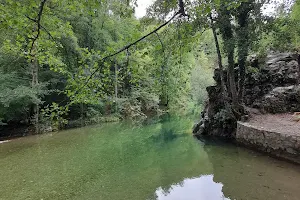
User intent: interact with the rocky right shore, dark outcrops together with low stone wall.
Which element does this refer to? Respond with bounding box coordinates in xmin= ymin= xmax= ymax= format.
xmin=193 ymin=53 xmax=300 ymax=164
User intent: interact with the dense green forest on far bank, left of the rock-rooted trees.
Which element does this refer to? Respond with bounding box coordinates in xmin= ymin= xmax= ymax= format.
xmin=0 ymin=0 xmax=211 ymax=131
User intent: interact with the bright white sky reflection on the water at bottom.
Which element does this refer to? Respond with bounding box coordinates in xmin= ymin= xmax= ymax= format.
xmin=155 ymin=175 xmax=230 ymax=200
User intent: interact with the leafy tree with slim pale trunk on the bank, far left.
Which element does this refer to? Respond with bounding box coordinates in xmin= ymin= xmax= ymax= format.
xmin=0 ymin=0 xmax=79 ymax=132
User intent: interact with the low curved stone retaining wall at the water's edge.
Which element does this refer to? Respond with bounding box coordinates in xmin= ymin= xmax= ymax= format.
xmin=235 ymin=122 xmax=300 ymax=164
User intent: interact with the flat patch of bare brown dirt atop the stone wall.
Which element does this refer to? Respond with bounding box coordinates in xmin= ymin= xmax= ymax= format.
xmin=248 ymin=114 xmax=300 ymax=136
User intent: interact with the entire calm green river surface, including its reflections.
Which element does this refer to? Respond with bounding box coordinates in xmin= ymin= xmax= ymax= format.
xmin=0 ymin=118 xmax=300 ymax=200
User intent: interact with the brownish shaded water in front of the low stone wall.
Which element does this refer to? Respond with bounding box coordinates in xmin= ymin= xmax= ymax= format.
xmin=204 ymin=139 xmax=300 ymax=200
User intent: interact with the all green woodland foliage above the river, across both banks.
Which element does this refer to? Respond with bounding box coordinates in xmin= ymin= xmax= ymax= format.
xmin=0 ymin=0 xmax=300 ymax=132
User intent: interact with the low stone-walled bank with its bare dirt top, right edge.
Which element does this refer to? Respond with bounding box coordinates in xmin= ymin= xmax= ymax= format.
xmin=235 ymin=114 xmax=300 ymax=164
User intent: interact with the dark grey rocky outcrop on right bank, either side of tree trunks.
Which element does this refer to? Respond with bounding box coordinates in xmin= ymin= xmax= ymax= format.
xmin=193 ymin=53 xmax=300 ymax=138
